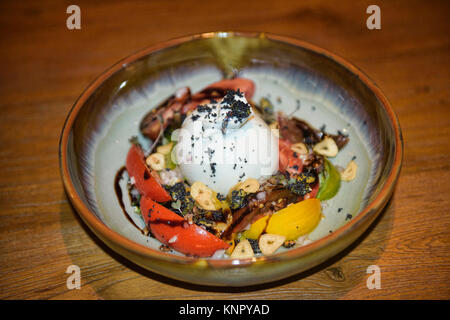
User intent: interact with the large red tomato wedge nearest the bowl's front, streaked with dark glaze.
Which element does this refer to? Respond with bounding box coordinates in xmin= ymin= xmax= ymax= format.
xmin=141 ymin=197 xmax=230 ymax=257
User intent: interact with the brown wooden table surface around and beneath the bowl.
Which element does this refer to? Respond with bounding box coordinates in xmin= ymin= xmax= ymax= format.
xmin=0 ymin=0 xmax=450 ymax=299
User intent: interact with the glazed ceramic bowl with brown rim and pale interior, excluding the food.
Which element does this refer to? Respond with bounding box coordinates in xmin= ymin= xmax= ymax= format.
xmin=60 ymin=32 xmax=403 ymax=286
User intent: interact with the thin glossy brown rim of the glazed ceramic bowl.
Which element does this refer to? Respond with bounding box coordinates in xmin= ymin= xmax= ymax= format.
xmin=59 ymin=32 xmax=403 ymax=268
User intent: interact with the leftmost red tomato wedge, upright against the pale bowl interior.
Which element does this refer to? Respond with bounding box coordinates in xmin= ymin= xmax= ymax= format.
xmin=126 ymin=144 xmax=172 ymax=202
